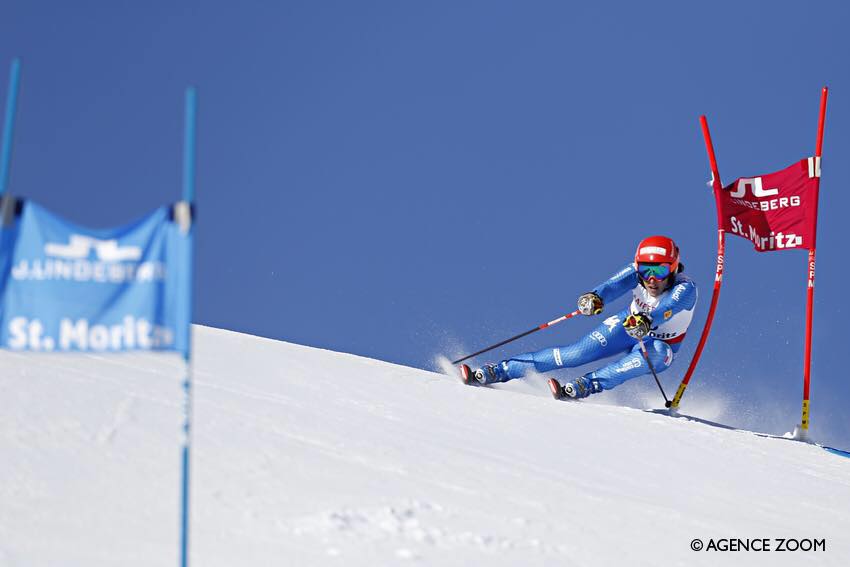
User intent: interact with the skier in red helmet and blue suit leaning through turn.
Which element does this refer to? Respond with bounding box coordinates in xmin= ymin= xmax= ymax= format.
xmin=461 ymin=236 xmax=697 ymax=399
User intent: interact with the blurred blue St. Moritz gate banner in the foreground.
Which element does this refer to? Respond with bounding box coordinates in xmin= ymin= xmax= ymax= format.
xmin=0 ymin=201 xmax=192 ymax=354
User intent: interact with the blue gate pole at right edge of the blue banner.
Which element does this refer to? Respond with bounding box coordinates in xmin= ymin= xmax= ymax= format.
xmin=180 ymin=88 xmax=197 ymax=567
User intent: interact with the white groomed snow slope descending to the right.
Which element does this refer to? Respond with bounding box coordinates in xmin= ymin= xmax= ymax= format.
xmin=0 ymin=327 xmax=850 ymax=567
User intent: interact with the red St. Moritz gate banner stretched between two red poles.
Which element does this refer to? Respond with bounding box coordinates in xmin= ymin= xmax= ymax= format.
xmin=719 ymin=157 xmax=820 ymax=252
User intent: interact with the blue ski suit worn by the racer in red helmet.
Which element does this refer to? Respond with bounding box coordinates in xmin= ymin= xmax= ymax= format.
xmin=497 ymin=264 xmax=697 ymax=390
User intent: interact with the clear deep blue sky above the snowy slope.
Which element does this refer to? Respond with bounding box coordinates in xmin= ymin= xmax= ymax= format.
xmin=0 ymin=0 xmax=850 ymax=446
